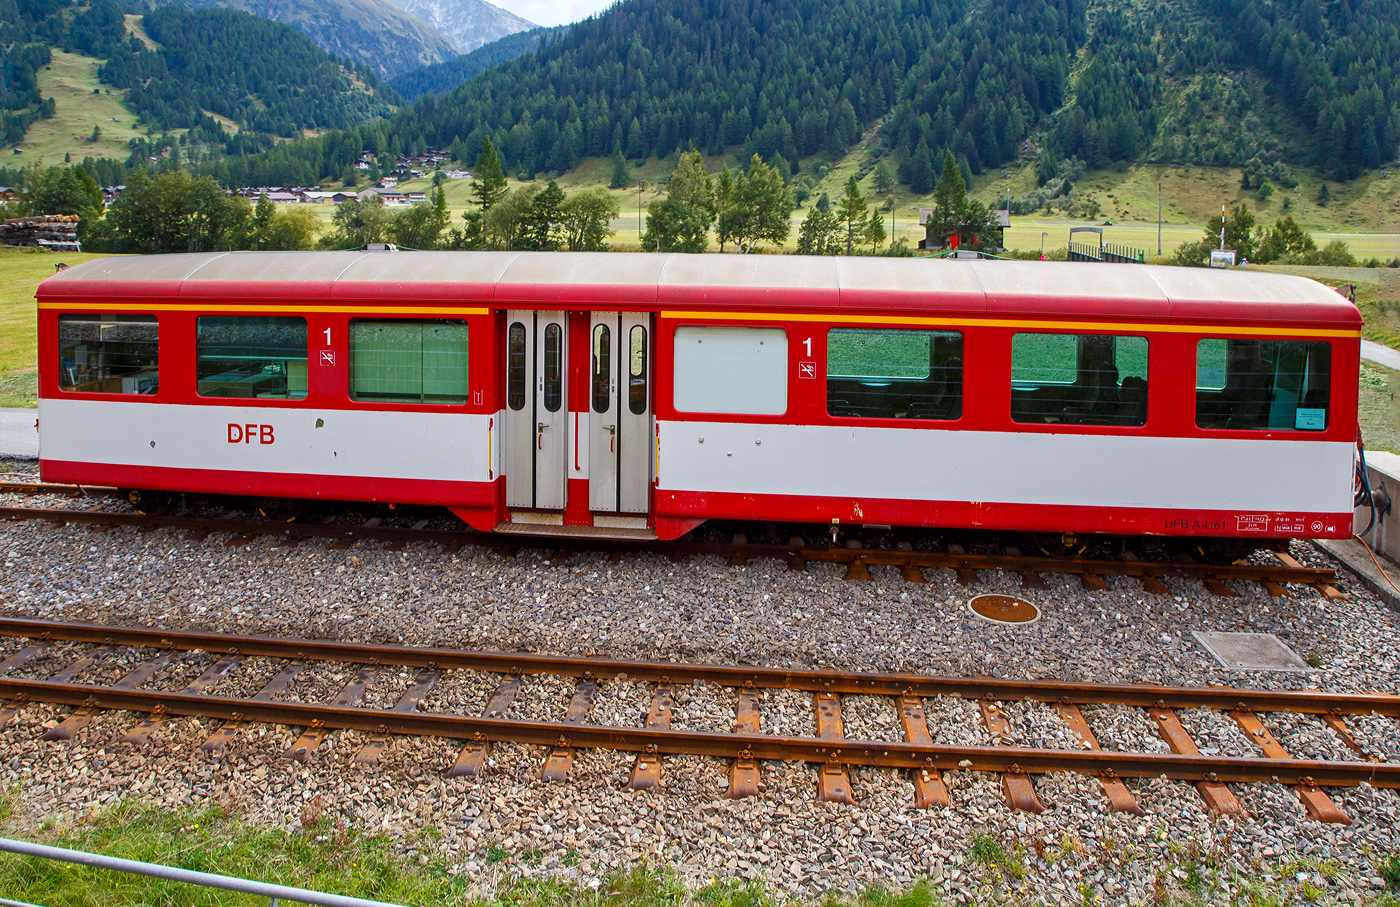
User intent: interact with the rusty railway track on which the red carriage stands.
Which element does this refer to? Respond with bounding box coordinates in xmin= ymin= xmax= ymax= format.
xmin=0 ymin=483 xmax=1345 ymax=599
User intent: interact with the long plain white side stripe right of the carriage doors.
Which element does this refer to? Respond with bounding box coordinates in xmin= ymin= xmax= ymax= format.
xmin=658 ymin=421 xmax=1354 ymax=514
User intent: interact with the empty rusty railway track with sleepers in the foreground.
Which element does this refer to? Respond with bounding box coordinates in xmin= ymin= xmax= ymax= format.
xmin=0 ymin=619 xmax=1400 ymax=823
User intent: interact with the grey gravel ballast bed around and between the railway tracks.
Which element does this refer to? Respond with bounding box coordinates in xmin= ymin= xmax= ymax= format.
xmin=0 ymin=497 xmax=1400 ymax=903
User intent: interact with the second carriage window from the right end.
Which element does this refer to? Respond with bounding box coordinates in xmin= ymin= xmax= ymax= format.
xmin=1011 ymin=333 xmax=1147 ymax=426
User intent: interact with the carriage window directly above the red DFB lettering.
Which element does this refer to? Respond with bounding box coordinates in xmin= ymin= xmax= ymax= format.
xmin=195 ymin=315 xmax=307 ymax=400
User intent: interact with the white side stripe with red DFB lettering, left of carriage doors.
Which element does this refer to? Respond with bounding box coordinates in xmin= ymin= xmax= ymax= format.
xmin=39 ymin=398 xmax=500 ymax=481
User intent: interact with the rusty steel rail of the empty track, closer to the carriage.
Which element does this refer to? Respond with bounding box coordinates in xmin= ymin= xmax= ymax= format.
xmin=0 ymin=617 xmax=1400 ymax=718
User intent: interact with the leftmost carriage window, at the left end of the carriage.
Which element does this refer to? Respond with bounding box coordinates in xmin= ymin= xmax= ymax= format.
xmin=59 ymin=315 xmax=160 ymax=393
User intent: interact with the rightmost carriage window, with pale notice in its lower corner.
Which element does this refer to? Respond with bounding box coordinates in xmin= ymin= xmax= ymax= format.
xmin=1196 ymin=337 xmax=1331 ymax=431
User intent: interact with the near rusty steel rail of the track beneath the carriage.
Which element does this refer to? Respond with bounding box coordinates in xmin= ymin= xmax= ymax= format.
xmin=0 ymin=507 xmax=1337 ymax=585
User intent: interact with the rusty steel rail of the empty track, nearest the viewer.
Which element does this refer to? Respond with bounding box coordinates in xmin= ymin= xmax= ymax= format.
xmin=0 ymin=677 xmax=1400 ymax=788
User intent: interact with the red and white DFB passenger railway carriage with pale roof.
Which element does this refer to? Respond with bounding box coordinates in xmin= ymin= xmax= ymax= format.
xmin=38 ymin=251 xmax=1361 ymax=540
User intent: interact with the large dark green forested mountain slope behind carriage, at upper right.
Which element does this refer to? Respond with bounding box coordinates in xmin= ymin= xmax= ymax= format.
xmin=366 ymin=0 xmax=1400 ymax=179
